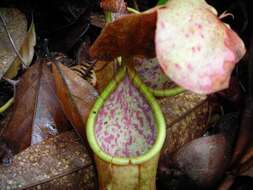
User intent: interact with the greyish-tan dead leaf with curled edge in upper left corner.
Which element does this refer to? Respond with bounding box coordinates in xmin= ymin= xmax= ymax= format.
xmin=0 ymin=9 xmax=36 ymax=78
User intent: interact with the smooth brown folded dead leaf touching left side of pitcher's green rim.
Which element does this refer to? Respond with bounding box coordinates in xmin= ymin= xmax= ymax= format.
xmin=52 ymin=61 xmax=98 ymax=142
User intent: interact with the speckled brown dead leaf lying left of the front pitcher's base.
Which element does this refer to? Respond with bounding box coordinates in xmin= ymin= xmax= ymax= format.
xmin=0 ymin=131 xmax=97 ymax=190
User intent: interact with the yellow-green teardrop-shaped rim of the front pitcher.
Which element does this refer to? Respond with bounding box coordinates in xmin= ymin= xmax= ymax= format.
xmin=86 ymin=66 xmax=166 ymax=165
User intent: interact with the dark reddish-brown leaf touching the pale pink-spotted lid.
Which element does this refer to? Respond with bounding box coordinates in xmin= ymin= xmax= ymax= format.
xmin=90 ymin=11 xmax=157 ymax=61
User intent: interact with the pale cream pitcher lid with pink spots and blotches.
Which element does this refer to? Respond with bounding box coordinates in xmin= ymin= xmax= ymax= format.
xmin=155 ymin=0 xmax=245 ymax=94
